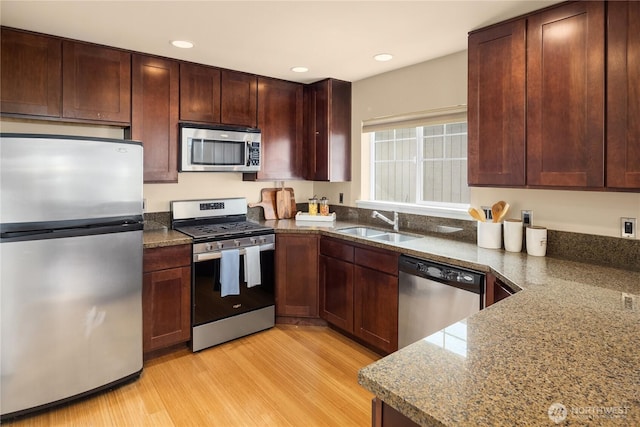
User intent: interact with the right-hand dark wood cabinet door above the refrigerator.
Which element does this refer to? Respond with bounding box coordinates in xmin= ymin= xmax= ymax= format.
xmin=62 ymin=41 xmax=131 ymax=124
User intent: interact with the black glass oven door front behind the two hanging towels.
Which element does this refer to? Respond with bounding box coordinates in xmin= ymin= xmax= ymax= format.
xmin=192 ymin=250 xmax=275 ymax=326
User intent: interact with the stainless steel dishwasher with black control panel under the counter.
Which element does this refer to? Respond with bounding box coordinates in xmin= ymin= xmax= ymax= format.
xmin=398 ymin=255 xmax=485 ymax=349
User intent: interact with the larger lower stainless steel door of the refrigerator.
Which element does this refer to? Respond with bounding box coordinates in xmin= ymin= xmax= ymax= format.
xmin=0 ymin=231 xmax=142 ymax=415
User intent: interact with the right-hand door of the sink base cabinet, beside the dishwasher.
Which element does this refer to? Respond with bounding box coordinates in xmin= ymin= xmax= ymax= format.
xmin=353 ymin=265 xmax=398 ymax=353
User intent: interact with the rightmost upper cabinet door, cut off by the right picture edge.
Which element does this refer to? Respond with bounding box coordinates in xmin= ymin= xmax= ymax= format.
xmin=607 ymin=1 xmax=640 ymax=190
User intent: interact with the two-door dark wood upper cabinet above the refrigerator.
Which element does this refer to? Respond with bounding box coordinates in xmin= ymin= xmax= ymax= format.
xmin=1 ymin=28 xmax=131 ymax=126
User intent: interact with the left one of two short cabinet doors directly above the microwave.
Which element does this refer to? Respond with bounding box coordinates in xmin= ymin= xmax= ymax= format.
xmin=180 ymin=63 xmax=220 ymax=123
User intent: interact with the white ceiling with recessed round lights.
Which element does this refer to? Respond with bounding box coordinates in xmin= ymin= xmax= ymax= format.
xmin=0 ymin=0 xmax=558 ymax=83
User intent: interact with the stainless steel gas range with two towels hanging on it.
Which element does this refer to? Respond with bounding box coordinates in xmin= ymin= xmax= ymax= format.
xmin=171 ymin=198 xmax=275 ymax=352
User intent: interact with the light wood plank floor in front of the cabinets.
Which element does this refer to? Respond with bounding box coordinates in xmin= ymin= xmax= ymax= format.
xmin=7 ymin=325 xmax=379 ymax=427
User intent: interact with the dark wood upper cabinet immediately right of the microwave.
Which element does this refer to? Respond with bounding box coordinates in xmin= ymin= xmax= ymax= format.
xmin=243 ymin=77 xmax=304 ymax=181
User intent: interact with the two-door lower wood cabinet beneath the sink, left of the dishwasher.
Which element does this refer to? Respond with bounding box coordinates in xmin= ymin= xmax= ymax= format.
xmin=320 ymin=237 xmax=399 ymax=353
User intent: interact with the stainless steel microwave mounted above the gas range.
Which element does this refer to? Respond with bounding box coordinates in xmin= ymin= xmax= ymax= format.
xmin=178 ymin=123 xmax=262 ymax=172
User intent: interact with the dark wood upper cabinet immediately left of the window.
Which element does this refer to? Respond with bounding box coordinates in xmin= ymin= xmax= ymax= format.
xmin=304 ymin=79 xmax=351 ymax=182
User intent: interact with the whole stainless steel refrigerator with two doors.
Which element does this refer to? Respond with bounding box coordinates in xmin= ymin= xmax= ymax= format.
xmin=0 ymin=134 xmax=143 ymax=419
